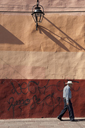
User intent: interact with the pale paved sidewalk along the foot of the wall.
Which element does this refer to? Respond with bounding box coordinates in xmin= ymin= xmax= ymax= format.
xmin=0 ymin=118 xmax=85 ymax=128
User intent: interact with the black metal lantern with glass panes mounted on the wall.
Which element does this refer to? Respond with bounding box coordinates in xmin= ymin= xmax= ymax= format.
xmin=32 ymin=0 xmax=44 ymax=30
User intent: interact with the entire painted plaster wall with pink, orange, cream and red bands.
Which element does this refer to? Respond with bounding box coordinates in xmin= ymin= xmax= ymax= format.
xmin=0 ymin=0 xmax=85 ymax=119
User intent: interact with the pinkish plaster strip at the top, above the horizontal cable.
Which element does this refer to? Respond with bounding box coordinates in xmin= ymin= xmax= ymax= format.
xmin=0 ymin=0 xmax=85 ymax=11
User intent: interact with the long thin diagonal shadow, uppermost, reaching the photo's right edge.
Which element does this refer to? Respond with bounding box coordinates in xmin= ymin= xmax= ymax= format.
xmin=44 ymin=17 xmax=85 ymax=51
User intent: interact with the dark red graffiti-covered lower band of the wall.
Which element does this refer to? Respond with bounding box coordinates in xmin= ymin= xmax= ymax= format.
xmin=0 ymin=79 xmax=85 ymax=119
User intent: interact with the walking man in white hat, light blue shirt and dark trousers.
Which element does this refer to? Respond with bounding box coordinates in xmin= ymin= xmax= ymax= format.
xmin=57 ymin=81 xmax=74 ymax=121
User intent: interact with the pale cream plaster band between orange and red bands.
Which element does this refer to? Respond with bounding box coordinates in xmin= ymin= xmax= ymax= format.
xmin=0 ymin=51 xmax=85 ymax=79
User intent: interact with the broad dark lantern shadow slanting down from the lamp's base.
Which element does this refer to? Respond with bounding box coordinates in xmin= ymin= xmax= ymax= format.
xmin=39 ymin=26 xmax=69 ymax=52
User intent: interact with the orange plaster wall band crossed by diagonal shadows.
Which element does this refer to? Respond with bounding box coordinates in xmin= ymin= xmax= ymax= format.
xmin=0 ymin=13 xmax=85 ymax=52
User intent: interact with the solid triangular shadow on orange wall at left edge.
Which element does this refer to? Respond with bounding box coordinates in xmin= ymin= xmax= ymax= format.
xmin=0 ymin=25 xmax=24 ymax=45
